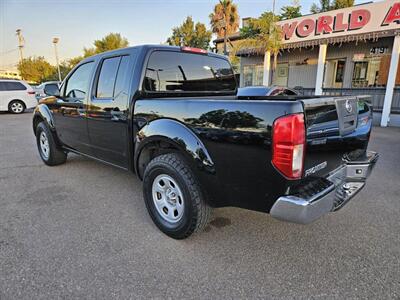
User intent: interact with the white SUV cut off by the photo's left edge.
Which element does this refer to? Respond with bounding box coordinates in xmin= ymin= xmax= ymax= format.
xmin=0 ymin=79 xmax=37 ymax=114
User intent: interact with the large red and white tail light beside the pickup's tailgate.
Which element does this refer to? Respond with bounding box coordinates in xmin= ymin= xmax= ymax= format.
xmin=272 ymin=114 xmax=306 ymax=179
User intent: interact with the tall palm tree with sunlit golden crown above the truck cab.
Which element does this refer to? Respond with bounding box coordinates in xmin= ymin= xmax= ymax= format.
xmin=209 ymin=0 xmax=239 ymax=55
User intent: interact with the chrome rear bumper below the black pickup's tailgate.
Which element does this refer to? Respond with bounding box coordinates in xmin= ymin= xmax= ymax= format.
xmin=270 ymin=151 xmax=379 ymax=224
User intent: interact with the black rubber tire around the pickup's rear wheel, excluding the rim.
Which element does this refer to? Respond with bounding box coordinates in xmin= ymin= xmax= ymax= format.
xmin=143 ymin=153 xmax=212 ymax=239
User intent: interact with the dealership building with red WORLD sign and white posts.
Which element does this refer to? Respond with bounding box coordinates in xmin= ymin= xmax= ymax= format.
xmin=217 ymin=0 xmax=400 ymax=126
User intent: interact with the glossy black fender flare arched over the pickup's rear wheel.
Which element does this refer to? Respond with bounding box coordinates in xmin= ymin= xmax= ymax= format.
xmin=135 ymin=119 xmax=215 ymax=177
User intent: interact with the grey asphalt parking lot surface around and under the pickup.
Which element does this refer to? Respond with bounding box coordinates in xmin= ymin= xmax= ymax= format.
xmin=0 ymin=113 xmax=400 ymax=300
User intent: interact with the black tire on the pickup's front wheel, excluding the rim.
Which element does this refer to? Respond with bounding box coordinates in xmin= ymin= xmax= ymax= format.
xmin=36 ymin=122 xmax=67 ymax=166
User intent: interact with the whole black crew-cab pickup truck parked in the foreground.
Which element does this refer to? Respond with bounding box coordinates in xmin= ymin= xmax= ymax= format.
xmin=33 ymin=45 xmax=378 ymax=239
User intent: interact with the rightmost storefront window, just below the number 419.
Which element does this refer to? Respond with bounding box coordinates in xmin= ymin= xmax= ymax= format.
xmin=352 ymin=57 xmax=381 ymax=87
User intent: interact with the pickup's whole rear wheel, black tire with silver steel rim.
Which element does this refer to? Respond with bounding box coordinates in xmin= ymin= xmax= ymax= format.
xmin=143 ymin=153 xmax=211 ymax=239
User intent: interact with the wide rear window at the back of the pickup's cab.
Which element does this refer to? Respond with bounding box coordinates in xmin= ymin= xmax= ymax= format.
xmin=144 ymin=51 xmax=236 ymax=93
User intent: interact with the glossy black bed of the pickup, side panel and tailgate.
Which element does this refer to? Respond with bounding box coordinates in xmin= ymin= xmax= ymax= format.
xmin=135 ymin=95 xmax=372 ymax=211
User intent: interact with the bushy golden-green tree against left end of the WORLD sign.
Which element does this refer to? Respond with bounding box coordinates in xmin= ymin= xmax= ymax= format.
xmin=233 ymin=12 xmax=282 ymax=68
